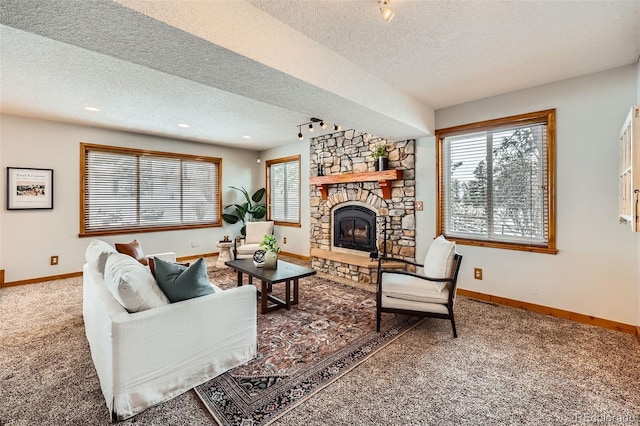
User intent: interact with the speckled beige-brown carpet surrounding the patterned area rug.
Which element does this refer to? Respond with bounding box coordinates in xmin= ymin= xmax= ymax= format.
xmin=0 ymin=256 xmax=640 ymax=425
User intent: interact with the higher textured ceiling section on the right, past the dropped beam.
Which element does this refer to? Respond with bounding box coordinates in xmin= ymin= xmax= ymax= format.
xmin=248 ymin=0 xmax=640 ymax=108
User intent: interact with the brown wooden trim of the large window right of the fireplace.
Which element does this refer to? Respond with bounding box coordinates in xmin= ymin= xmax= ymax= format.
xmin=435 ymin=109 xmax=558 ymax=254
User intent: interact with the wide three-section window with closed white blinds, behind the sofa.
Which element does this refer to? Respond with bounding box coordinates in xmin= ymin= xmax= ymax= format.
xmin=80 ymin=143 xmax=221 ymax=235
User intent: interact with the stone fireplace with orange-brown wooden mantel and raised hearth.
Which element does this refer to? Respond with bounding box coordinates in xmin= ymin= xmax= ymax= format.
xmin=310 ymin=130 xmax=415 ymax=283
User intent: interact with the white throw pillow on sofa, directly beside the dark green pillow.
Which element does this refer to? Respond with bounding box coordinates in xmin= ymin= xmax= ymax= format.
xmin=104 ymin=253 xmax=169 ymax=313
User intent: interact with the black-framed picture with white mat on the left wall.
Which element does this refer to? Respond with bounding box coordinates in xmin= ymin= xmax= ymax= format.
xmin=7 ymin=167 xmax=53 ymax=210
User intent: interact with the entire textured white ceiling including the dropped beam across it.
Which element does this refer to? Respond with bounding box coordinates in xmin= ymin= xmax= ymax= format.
xmin=0 ymin=0 xmax=640 ymax=150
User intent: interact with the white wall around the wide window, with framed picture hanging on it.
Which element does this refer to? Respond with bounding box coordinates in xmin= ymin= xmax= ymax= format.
xmin=0 ymin=115 xmax=261 ymax=281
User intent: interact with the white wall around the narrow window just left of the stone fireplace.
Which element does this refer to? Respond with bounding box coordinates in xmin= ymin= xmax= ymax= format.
xmin=260 ymin=138 xmax=311 ymax=256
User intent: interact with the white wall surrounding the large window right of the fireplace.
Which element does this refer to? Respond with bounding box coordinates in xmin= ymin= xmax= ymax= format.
xmin=416 ymin=65 xmax=640 ymax=324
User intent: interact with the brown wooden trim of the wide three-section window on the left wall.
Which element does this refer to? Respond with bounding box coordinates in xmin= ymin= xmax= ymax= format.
xmin=78 ymin=142 xmax=222 ymax=237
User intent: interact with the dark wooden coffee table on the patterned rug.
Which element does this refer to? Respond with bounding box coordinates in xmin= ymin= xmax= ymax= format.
xmin=225 ymin=259 xmax=316 ymax=314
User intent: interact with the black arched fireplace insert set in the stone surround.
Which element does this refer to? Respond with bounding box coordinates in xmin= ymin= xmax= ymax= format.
xmin=333 ymin=206 xmax=377 ymax=253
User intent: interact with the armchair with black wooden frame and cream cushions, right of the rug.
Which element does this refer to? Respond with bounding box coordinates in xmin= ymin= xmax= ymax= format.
xmin=376 ymin=236 xmax=462 ymax=337
